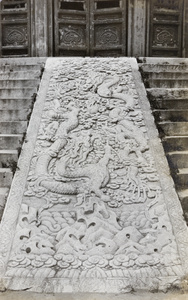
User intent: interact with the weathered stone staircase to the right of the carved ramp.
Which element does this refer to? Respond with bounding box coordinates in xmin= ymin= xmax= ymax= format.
xmin=138 ymin=58 xmax=188 ymax=224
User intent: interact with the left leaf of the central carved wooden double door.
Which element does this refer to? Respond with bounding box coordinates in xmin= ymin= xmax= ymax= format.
xmin=54 ymin=0 xmax=89 ymax=56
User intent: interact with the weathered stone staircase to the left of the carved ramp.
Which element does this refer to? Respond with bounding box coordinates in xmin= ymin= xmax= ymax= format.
xmin=0 ymin=58 xmax=45 ymax=219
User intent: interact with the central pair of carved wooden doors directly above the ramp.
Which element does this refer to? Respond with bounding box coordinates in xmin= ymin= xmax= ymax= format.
xmin=54 ymin=0 xmax=126 ymax=56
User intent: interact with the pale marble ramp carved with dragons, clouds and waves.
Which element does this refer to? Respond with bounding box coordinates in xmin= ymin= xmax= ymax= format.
xmin=0 ymin=58 xmax=188 ymax=293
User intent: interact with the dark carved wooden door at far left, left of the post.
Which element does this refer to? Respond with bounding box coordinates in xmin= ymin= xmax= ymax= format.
xmin=0 ymin=0 xmax=30 ymax=57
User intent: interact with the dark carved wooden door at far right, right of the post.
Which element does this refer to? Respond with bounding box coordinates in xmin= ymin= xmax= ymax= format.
xmin=150 ymin=0 xmax=183 ymax=57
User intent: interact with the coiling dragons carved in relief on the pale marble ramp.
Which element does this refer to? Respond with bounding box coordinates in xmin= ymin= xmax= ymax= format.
xmin=26 ymin=76 xmax=146 ymax=201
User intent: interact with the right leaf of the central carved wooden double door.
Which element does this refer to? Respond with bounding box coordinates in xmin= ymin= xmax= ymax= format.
xmin=90 ymin=0 xmax=127 ymax=56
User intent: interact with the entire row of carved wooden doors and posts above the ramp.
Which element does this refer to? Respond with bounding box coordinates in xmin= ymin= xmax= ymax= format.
xmin=0 ymin=0 xmax=185 ymax=57
